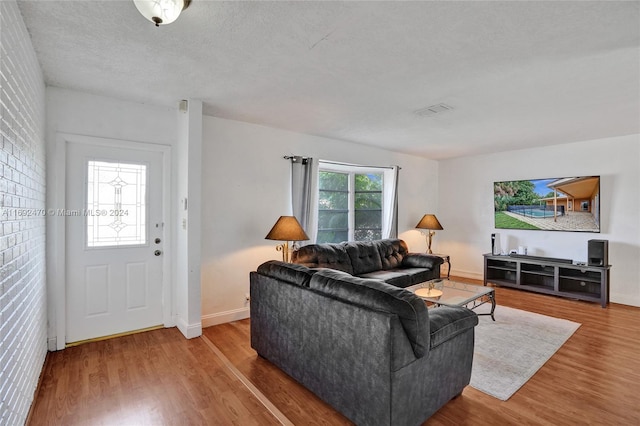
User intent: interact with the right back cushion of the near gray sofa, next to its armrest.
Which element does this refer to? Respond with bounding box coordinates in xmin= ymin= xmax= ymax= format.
xmin=309 ymin=269 xmax=429 ymax=358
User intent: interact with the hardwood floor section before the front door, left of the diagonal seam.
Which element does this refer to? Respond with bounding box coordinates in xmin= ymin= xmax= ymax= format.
xmin=28 ymin=328 xmax=279 ymax=426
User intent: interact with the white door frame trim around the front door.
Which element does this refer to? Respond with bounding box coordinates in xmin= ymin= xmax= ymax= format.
xmin=47 ymin=133 xmax=175 ymax=350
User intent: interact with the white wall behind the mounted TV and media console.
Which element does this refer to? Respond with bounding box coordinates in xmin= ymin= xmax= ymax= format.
xmin=436 ymin=135 xmax=640 ymax=306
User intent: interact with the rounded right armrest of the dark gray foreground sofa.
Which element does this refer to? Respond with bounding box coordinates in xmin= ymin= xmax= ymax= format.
xmin=429 ymin=306 xmax=478 ymax=349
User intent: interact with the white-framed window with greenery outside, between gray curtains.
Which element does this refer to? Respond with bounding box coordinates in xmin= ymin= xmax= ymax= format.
xmin=316 ymin=162 xmax=394 ymax=243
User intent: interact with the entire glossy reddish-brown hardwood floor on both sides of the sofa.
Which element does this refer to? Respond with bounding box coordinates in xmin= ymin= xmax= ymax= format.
xmin=28 ymin=280 xmax=640 ymax=425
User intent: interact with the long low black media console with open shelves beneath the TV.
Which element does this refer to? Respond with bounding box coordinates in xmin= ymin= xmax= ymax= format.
xmin=484 ymin=254 xmax=611 ymax=308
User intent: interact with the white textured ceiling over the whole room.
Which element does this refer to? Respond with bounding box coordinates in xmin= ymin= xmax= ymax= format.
xmin=18 ymin=0 xmax=640 ymax=159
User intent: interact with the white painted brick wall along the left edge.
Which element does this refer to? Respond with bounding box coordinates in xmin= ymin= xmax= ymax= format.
xmin=0 ymin=1 xmax=47 ymax=426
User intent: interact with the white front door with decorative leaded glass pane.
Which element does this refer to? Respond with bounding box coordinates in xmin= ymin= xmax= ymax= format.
xmin=63 ymin=143 xmax=165 ymax=343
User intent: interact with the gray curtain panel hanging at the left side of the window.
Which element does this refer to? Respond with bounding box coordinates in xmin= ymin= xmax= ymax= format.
xmin=289 ymin=155 xmax=313 ymax=236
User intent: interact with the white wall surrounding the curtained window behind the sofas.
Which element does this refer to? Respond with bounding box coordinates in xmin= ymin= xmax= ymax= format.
xmin=202 ymin=116 xmax=438 ymax=326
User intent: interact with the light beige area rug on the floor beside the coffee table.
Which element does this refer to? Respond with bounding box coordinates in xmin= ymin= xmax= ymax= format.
xmin=471 ymin=305 xmax=580 ymax=401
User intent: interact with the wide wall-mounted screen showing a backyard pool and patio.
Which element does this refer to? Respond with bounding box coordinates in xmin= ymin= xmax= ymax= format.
xmin=493 ymin=176 xmax=600 ymax=232
